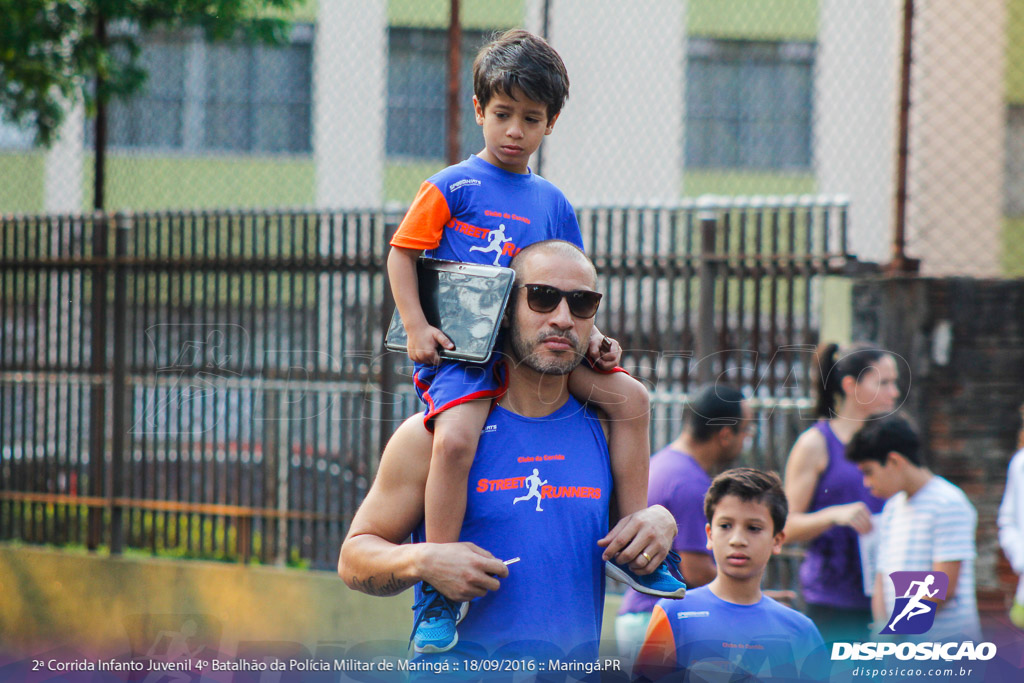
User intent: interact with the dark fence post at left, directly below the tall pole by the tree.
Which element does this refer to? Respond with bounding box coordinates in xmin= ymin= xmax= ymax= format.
xmin=86 ymin=211 xmax=109 ymax=551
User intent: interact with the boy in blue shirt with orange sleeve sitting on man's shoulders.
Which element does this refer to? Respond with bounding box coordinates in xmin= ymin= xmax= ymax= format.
xmin=387 ymin=29 xmax=686 ymax=652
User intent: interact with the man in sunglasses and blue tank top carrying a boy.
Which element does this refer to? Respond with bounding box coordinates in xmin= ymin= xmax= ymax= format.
xmin=338 ymin=241 xmax=677 ymax=676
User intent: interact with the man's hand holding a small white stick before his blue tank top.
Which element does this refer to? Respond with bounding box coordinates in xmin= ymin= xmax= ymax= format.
xmin=419 ymin=543 xmax=509 ymax=602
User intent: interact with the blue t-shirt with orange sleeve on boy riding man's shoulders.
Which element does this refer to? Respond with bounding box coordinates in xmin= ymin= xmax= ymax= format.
xmin=391 ymin=155 xmax=583 ymax=266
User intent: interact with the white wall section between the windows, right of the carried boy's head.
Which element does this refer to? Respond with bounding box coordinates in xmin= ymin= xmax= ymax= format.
xmin=543 ymin=0 xmax=686 ymax=206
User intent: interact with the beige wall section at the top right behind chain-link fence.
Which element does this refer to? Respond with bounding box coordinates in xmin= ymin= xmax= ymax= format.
xmin=907 ymin=0 xmax=1007 ymax=276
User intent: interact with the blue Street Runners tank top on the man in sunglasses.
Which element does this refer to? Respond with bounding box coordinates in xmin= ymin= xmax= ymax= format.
xmin=414 ymin=397 xmax=611 ymax=661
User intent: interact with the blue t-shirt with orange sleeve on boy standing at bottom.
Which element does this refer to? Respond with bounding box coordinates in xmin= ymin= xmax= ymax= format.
xmin=636 ymin=586 xmax=828 ymax=681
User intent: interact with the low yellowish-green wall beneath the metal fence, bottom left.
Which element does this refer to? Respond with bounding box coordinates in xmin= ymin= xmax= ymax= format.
xmin=0 ymin=546 xmax=618 ymax=663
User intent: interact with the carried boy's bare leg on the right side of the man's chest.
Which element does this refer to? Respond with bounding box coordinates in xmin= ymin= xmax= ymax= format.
xmin=569 ymin=366 xmax=655 ymax=518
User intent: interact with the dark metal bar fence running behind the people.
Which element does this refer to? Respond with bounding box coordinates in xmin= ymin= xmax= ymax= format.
xmin=0 ymin=198 xmax=853 ymax=567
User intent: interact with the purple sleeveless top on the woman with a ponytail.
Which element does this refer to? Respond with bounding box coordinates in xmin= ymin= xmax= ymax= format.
xmin=800 ymin=420 xmax=885 ymax=609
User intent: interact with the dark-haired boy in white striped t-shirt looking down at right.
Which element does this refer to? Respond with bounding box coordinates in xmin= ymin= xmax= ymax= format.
xmin=846 ymin=414 xmax=981 ymax=641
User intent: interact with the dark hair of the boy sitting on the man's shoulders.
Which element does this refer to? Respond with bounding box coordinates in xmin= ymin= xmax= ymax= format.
xmin=473 ymin=29 xmax=569 ymax=121
